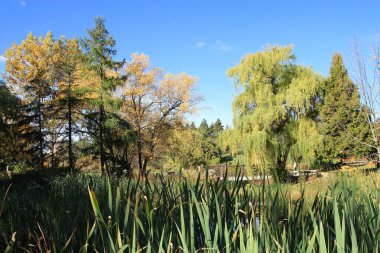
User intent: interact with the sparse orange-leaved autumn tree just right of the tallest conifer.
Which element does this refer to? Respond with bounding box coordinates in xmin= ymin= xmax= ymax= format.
xmin=121 ymin=51 xmax=197 ymax=174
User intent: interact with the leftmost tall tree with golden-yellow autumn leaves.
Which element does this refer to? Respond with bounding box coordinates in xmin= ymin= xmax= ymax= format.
xmin=5 ymin=32 xmax=56 ymax=167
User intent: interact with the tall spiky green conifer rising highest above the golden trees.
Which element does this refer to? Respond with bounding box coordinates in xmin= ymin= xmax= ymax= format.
xmin=81 ymin=18 xmax=123 ymax=173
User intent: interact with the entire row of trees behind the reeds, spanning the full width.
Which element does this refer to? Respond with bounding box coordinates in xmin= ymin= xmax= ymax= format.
xmin=0 ymin=18 xmax=380 ymax=178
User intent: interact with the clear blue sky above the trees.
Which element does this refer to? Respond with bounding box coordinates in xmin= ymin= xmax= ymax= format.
xmin=0 ymin=0 xmax=380 ymax=125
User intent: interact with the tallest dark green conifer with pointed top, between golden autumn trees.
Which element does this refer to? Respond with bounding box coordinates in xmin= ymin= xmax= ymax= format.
xmin=82 ymin=18 xmax=121 ymax=173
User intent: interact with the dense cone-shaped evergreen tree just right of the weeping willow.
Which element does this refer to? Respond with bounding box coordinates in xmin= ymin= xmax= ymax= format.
xmin=320 ymin=54 xmax=371 ymax=163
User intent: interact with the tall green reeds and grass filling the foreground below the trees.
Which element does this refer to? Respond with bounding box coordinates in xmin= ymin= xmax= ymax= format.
xmin=0 ymin=169 xmax=380 ymax=252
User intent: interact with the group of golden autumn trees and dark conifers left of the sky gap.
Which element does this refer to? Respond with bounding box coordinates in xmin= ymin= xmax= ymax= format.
xmin=0 ymin=18 xmax=199 ymax=176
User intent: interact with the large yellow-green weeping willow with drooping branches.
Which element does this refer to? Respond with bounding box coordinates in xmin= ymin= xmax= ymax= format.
xmin=221 ymin=46 xmax=322 ymax=179
